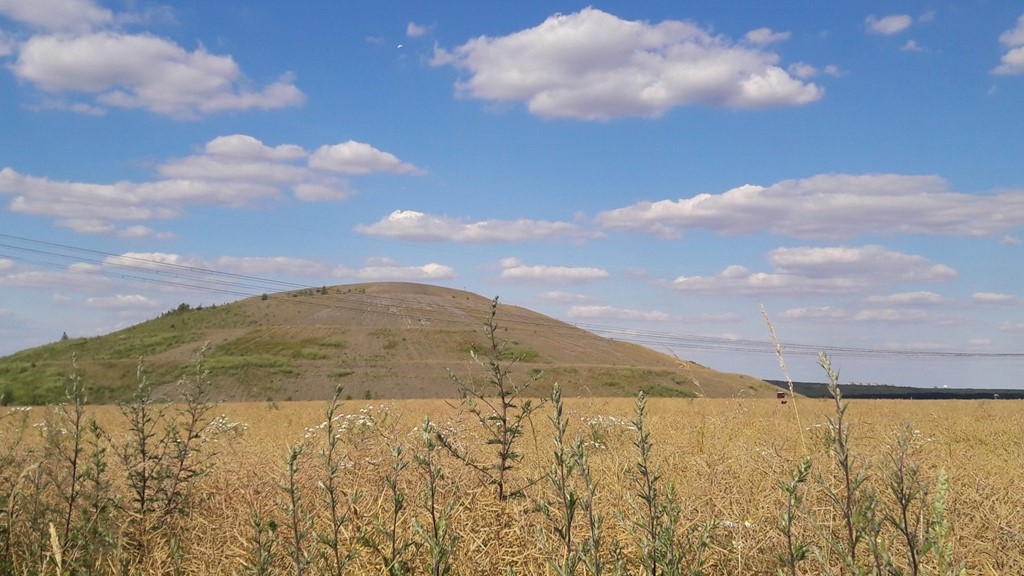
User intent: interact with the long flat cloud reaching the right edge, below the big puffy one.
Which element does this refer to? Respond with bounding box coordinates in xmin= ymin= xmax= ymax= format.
xmin=597 ymin=174 xmax=1024 ymax=240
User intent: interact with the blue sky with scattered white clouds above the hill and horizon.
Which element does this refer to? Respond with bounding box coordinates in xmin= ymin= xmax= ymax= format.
xmin=0 ymin=0 xmax=1024 ymax=386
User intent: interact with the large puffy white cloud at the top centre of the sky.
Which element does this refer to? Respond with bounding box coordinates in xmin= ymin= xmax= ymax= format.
xmin=432 ymin=8 xmax=824 ymax=120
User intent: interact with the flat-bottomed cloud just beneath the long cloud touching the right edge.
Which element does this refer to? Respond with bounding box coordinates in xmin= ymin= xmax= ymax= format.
xmin=669 ymin=245 xmax=956 ymax=295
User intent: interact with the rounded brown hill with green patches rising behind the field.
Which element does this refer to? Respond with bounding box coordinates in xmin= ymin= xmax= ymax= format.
xmin=0 ymin=283 xmax=774 ymax=404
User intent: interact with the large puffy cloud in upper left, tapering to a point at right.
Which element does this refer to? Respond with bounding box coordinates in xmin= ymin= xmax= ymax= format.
xmin=10 ymin=31 xmax=305 ymax=118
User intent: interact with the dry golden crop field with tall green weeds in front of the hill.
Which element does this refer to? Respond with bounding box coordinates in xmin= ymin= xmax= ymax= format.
xmin=0 ymin=387 xmax=1024 ymax=574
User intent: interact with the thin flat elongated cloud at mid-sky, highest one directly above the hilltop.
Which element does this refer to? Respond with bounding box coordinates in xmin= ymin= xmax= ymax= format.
xmin=355 ymin=210 xmax=595 ymax=243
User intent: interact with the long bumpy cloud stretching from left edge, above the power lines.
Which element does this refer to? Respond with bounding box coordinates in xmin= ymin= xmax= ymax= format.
xmin=0 ymin=134 xmax=415 ymax=231
